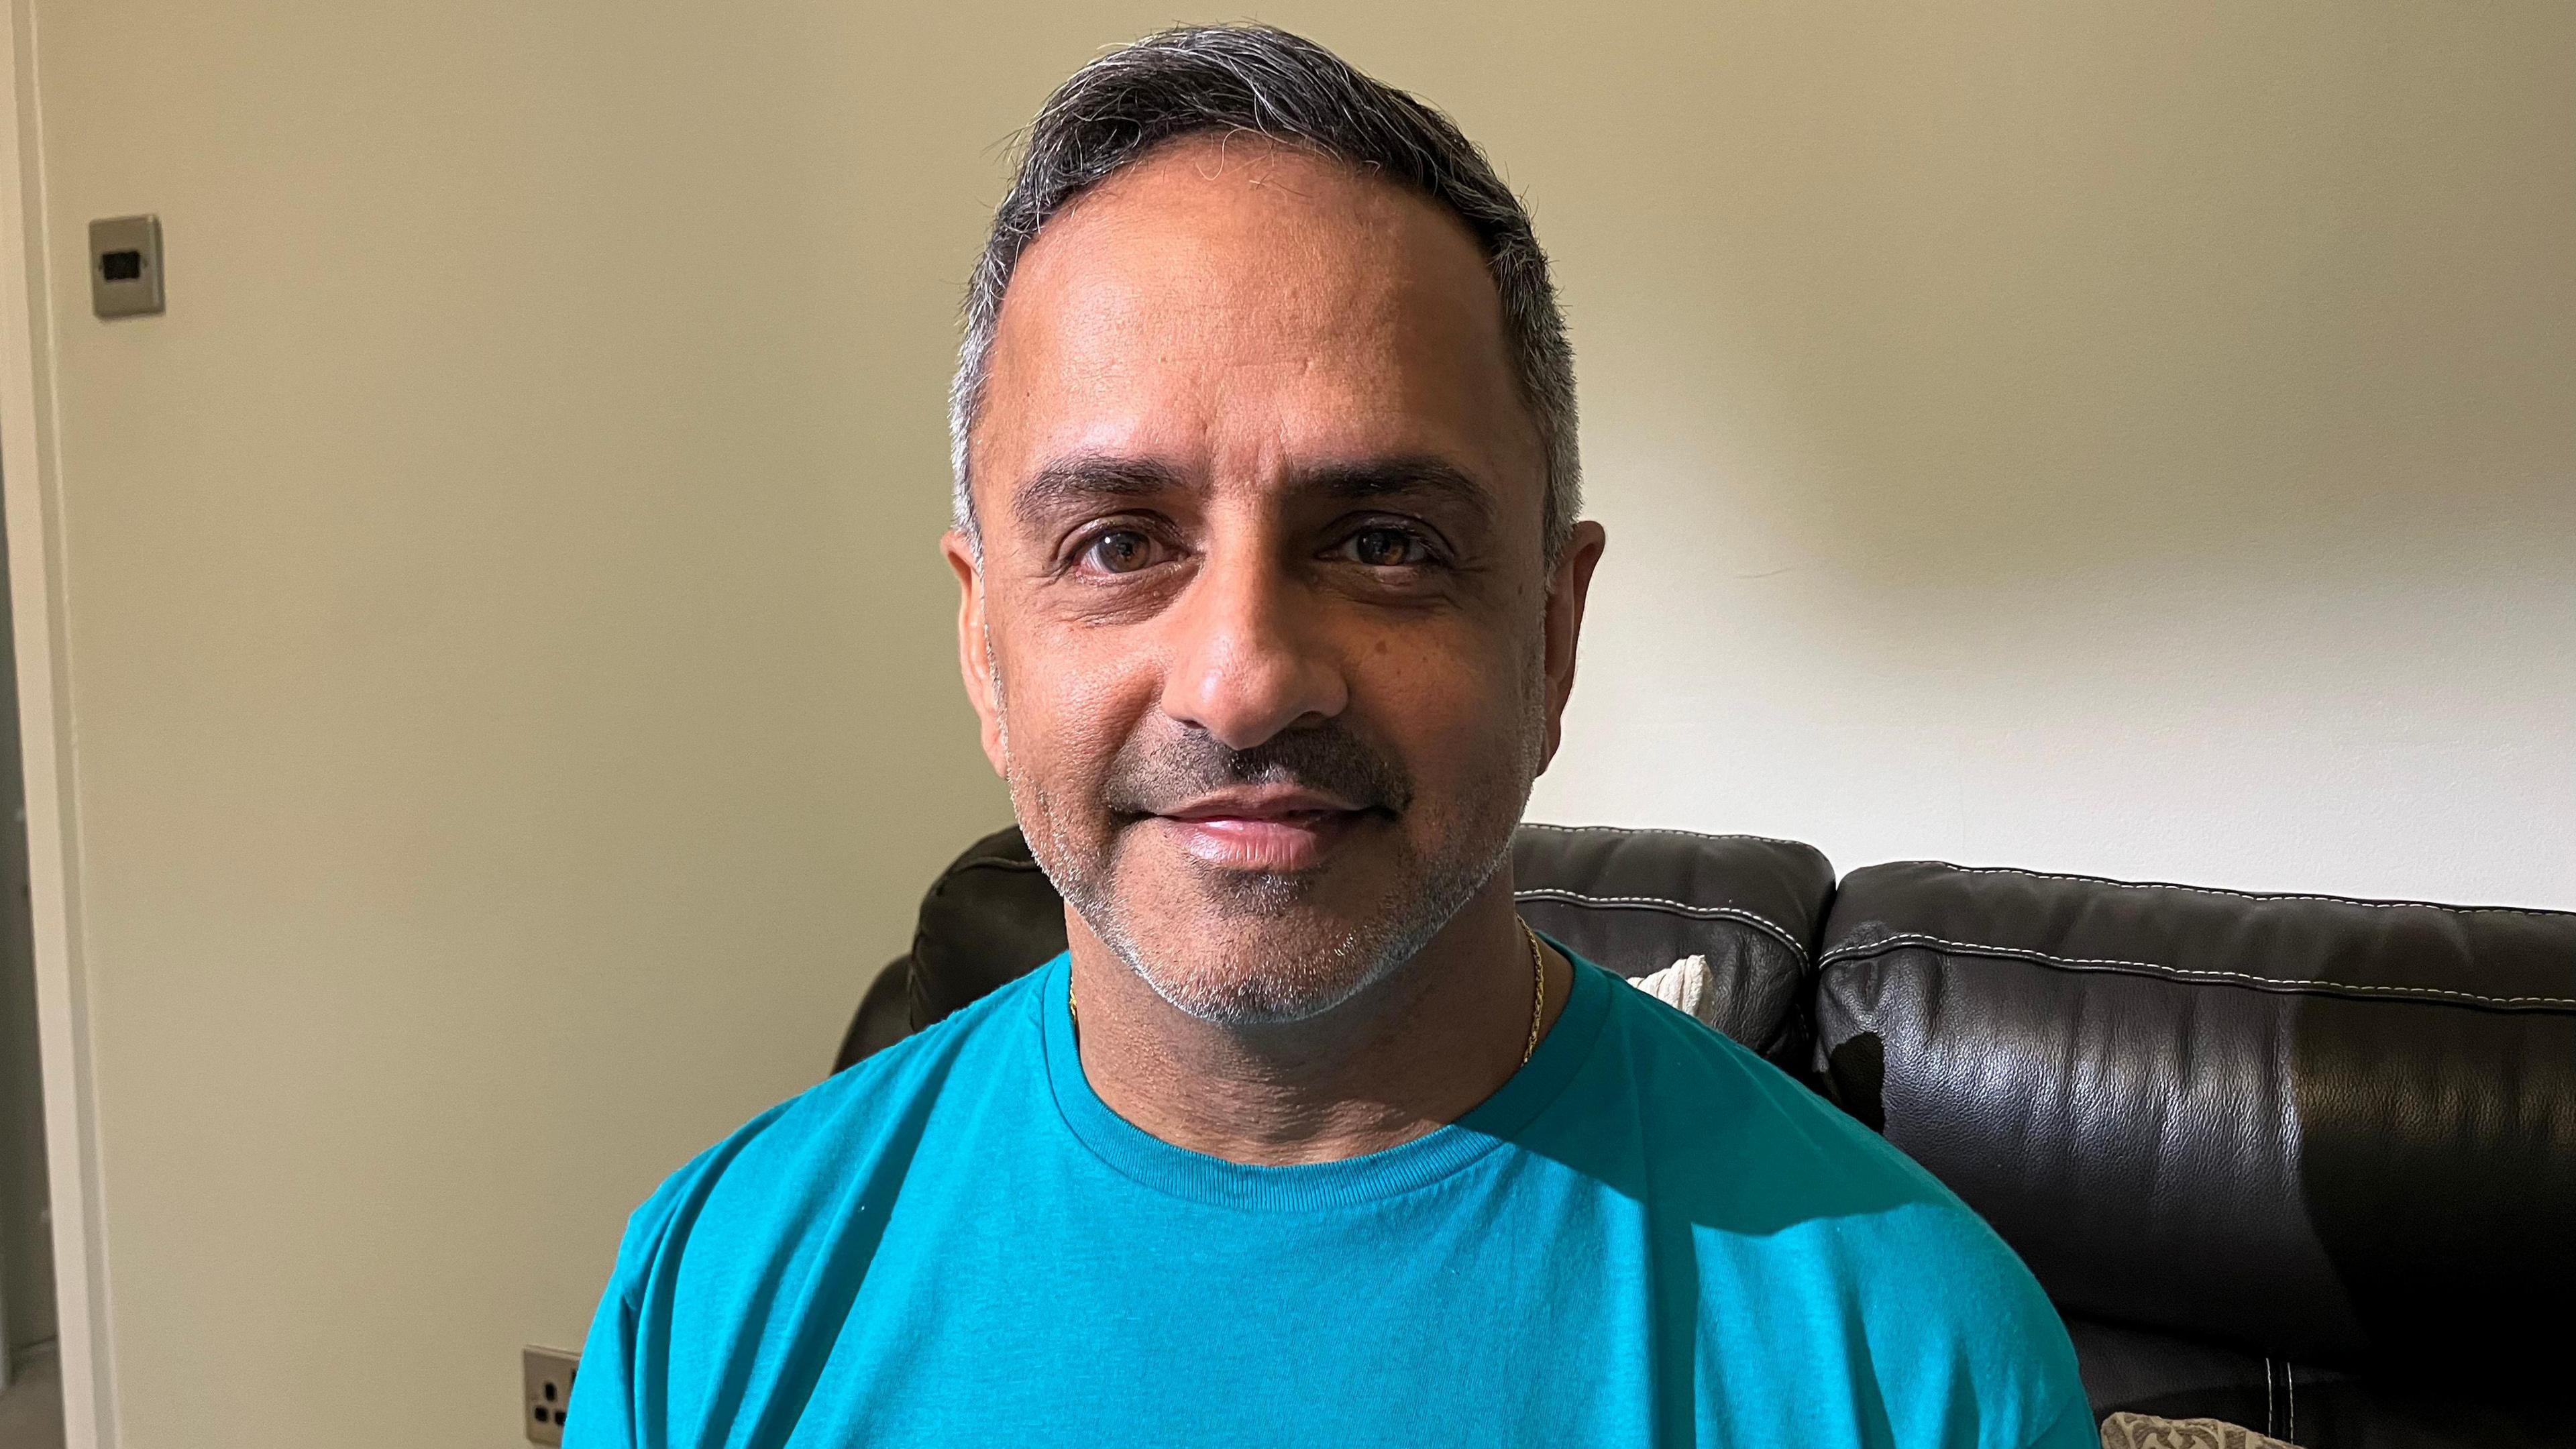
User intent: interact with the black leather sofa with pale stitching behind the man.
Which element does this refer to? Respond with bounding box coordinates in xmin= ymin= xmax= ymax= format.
xmin=840 ymin=825 xmax=2576 ymax=1449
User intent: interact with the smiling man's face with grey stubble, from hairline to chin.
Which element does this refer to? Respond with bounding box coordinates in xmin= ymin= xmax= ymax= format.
xmin=948 ymin=140 xmax=1600 ymax=1024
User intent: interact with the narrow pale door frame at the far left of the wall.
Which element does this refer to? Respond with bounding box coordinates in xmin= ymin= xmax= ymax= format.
xmin=0 ymin=0 xmax=119 ymax=1449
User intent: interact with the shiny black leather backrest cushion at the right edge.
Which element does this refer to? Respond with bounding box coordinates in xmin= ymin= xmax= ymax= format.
xmin=1816 ymin=864 xmax=2576 ymax=1382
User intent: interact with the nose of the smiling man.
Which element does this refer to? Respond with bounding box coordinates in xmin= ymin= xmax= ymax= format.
xmin=1162 ymin=539 xmax=1350 ymax=750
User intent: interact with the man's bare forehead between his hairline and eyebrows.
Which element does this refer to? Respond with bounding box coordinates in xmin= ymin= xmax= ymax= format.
xmin=971 ymin=137 xmax=1540 ymax=516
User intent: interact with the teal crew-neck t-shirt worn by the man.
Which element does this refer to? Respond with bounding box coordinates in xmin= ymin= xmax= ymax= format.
xmin=567 ymin=957 xmax=2100 ymax=1449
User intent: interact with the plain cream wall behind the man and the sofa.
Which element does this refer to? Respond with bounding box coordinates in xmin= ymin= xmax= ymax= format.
xmin=10 ymin=0 xmax=2576 ymax=1449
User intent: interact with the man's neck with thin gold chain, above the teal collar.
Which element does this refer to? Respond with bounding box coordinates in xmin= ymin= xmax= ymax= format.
xmin=1064 ymin=866 xmax=1574 ymax=1163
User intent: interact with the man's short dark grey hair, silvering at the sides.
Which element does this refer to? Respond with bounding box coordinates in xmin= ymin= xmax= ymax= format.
xmin=948 ymin=25 xmax=1582 ymax=562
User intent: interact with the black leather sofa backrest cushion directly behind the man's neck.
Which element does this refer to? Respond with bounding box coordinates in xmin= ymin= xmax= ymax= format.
xmin=885 ymin=825 xmax=1834 ymax=1067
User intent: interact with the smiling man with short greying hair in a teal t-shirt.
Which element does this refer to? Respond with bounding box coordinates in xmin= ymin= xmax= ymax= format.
xmin=570 ymin=28 xmax=2094 ymax=1449
